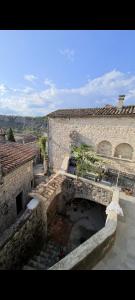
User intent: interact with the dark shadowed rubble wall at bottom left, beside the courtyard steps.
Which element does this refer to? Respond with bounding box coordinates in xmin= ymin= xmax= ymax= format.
xmin=0 ymin=198 xmax=46 ymax=270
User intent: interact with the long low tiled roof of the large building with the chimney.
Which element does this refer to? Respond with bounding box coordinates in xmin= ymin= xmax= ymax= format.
xmin=48 ymin=105 xmax=135 ymax=118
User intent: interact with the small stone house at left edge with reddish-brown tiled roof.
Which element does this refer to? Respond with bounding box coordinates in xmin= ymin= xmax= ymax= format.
xmin=0 ymin=142 xmax=35 ymax=233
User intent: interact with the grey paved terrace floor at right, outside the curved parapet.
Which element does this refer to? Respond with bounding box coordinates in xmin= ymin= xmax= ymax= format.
xmin=93 ymin=193 xmax=135 ymax=270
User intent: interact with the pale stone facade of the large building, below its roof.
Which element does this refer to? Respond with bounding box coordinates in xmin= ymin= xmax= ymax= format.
xmin=48 ymin=117 xmax=135 ymax=171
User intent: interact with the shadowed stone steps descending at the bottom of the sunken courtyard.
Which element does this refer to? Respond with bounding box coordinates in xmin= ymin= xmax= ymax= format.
xmin=23 ymin=240 xmax=65 ymax=270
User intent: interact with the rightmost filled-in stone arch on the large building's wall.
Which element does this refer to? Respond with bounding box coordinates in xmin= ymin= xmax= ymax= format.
xmin=114 ymin=143 xmax=133 ymax=159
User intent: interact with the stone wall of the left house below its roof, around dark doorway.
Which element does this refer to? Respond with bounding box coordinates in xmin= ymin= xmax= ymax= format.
xmin=0 ymin=161 xmax=33 ymax=233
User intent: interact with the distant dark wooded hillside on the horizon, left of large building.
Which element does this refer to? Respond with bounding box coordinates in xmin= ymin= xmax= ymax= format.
xmin=0 ymin=115 xmax=47 ymax=134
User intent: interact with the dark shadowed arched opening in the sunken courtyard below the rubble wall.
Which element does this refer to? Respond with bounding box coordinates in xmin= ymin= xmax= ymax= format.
xmin=47 ymin=194 xmax=106 ymax=248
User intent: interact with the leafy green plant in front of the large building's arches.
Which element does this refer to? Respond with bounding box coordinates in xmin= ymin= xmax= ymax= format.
xmin=72 ymin=144 xmax=105 ymax=180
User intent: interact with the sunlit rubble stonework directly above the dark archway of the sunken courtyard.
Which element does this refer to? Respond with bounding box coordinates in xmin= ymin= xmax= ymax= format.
xmin=30 ymin=171 xmax=113 ymax=223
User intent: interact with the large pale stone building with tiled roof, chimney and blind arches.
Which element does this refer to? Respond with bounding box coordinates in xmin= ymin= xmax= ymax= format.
xmin=48 ymin=95 xmax=135 ymax=174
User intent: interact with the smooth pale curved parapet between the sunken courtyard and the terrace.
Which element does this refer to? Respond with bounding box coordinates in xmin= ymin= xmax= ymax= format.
xmin=49 ymin=190 xmax=119 ymax=270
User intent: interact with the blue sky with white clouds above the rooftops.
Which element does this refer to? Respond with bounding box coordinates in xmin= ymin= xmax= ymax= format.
xmin=0 ymin=30 xmax=135 ymax=116
